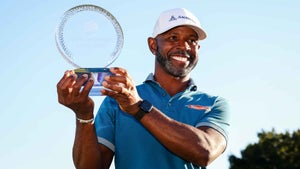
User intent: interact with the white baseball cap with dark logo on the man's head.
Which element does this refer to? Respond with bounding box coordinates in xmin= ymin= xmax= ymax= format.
xmin=152 ymin=8 xmax=206 ymax=40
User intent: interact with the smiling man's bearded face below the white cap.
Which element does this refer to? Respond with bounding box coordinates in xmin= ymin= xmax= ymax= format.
xmin=155 ymin=26 xmax=200 ymax=77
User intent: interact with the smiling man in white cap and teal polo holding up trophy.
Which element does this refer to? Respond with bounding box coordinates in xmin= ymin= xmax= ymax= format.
xmin=57 ymin=8 xmax=229 ymax=169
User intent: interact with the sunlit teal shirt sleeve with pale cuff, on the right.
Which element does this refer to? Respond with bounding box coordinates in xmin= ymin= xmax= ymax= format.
xmin=196 ymin=97 xmax=230 ymax=141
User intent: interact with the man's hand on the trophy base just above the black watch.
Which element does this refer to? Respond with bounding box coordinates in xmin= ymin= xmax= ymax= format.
xmin=101 ymin=68 xmax=142 ymax=115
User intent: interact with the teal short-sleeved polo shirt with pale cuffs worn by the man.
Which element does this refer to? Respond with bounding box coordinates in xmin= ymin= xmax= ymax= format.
xmin=95 ymin=74 xmax=229 ymax=169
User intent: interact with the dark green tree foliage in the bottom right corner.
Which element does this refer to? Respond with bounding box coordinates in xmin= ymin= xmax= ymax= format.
xmin=229 ymin=129 xmax=300 ymax=169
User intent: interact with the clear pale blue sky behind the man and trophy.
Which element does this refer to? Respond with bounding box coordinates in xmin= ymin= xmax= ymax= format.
xmin=0 ymin=0 xmax=300 ymax=169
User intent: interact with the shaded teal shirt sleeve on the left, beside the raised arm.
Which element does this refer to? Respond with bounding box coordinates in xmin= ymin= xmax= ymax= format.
xmin=95 ymin=97 xmax=118 ymax=152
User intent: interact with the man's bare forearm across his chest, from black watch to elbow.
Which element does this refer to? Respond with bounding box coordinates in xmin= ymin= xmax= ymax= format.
xmin=140 ymin=108 xmax=226 ymax=166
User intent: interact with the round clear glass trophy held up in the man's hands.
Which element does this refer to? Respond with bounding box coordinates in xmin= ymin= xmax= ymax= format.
xmin=55 ymin=4 xmax=124 ymax=96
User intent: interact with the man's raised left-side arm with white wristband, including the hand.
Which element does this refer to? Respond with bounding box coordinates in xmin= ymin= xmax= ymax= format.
xmin=57 ymin=71 xmax=113 ymax=169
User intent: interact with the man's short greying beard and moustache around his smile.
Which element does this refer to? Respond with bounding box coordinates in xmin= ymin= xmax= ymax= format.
xmin=155 ymin=48 xmax=198 ymax=78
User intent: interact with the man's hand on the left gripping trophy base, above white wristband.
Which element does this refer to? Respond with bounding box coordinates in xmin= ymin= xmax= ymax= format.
xmin=56 ymin=71 xmax=94 ymax=119
